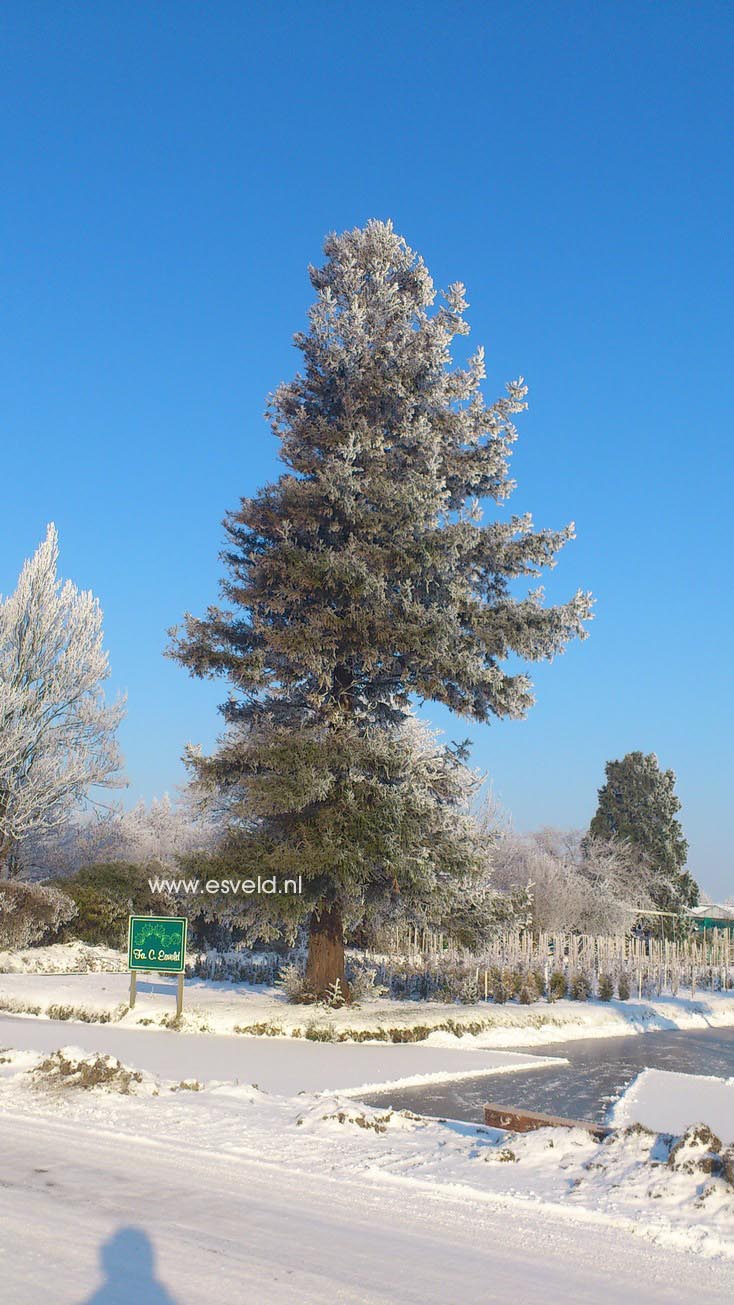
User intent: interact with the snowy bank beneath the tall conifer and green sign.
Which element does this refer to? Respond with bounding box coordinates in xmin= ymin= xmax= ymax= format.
xmin=0 ymin=949 xmax=734 ymax=1048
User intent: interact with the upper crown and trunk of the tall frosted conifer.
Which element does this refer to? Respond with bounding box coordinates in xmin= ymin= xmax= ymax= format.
xmin=172 ymin=222 xmax=590 ymax=979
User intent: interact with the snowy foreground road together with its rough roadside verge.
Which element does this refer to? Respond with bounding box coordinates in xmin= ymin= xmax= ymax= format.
xmin=0 ymin=1032 xmax=734 ymax=1305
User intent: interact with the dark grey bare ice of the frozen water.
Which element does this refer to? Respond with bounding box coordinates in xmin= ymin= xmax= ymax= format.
xmin=364 ymin=1028 xmax=734 ymax=1124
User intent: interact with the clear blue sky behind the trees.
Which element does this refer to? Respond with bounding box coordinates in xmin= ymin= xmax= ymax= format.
xmin=0 ymin=0 xmax=734 ymax=894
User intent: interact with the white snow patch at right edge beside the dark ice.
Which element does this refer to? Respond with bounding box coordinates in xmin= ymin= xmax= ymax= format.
xmin=611 ymin=1069 xmax=734 ymax=1144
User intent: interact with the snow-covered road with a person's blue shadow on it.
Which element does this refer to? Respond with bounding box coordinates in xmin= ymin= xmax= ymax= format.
xmin=0 ymin=1114 xmax=734 ymax=1305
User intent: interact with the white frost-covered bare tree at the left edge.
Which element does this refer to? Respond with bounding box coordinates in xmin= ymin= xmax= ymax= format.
xmin=0 ymin=526 xmax=124 ymax=878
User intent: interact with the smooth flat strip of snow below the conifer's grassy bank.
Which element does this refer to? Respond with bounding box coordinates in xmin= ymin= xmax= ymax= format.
xmin=0 ymin=1015 xmax=563 ymax=1096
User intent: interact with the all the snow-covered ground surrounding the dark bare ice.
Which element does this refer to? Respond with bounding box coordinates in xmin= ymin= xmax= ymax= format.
xmin=0 ymin=949 xmax=734 ymax=1305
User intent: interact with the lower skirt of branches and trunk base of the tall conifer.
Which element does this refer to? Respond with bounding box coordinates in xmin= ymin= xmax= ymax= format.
xmin=182 ymin=716 xmax=496 ymax=992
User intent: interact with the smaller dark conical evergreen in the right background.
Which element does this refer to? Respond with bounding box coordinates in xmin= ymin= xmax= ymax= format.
xmin=589 ymin=752 xmax=699 ymax=911
